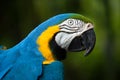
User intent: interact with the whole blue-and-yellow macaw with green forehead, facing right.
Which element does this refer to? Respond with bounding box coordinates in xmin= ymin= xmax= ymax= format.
xmin=0 ymin=13 xmax=96 ymax=80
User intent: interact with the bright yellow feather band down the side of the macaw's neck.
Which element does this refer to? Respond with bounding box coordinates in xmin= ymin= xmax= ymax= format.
xmin=37 ymin=25 xmax=59 ymax=64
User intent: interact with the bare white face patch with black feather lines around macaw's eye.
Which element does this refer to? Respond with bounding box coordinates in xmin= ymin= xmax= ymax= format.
xmin=55 ymin=19 xmax=93 ymax=50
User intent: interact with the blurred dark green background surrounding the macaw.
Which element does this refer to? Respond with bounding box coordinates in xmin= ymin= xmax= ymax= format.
xmin=0 ymin=0 xmax=120 ymax=80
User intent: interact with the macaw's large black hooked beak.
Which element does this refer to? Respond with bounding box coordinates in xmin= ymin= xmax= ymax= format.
xmin=68 ymin=29 xmax=96 ymax=56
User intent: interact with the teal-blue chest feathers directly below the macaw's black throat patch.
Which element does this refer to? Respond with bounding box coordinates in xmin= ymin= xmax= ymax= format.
xmin=39 ymin=61 xmax=64 ymax=80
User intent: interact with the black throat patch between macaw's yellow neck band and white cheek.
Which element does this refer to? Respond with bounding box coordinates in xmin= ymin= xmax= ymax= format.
xmin=49 ymin=33 xmax=67 ymax=60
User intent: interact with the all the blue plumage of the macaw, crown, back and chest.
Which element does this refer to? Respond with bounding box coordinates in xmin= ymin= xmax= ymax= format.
xmin=0 ymin=14 xmax=76 ymax=80
